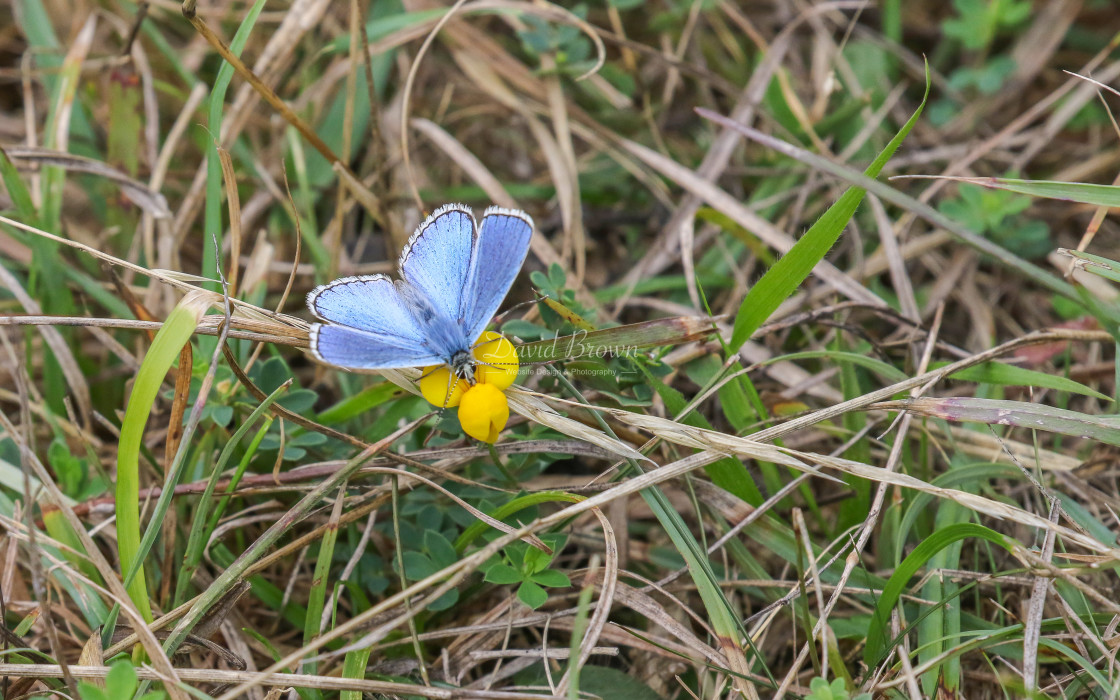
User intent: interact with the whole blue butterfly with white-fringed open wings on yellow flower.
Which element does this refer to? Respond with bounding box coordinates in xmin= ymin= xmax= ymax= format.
xmin=307 ymin=204 xmax=533 ymax=380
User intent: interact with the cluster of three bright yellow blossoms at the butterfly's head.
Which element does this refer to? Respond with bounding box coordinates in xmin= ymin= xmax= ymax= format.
xmin=420 ymin=330 xmax=520 ymax=442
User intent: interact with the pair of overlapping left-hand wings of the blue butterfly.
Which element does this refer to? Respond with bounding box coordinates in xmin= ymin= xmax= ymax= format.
xmin=307 ymin=274 xmax=442 ymax=370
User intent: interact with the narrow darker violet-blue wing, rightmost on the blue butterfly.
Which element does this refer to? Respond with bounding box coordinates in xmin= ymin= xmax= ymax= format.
xmin=459 ymin=206 xmax=533 ymax=343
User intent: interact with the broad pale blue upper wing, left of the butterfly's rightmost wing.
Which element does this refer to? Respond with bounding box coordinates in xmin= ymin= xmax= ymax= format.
xmin=400 ymin=204 xmax=478 ymax=329
